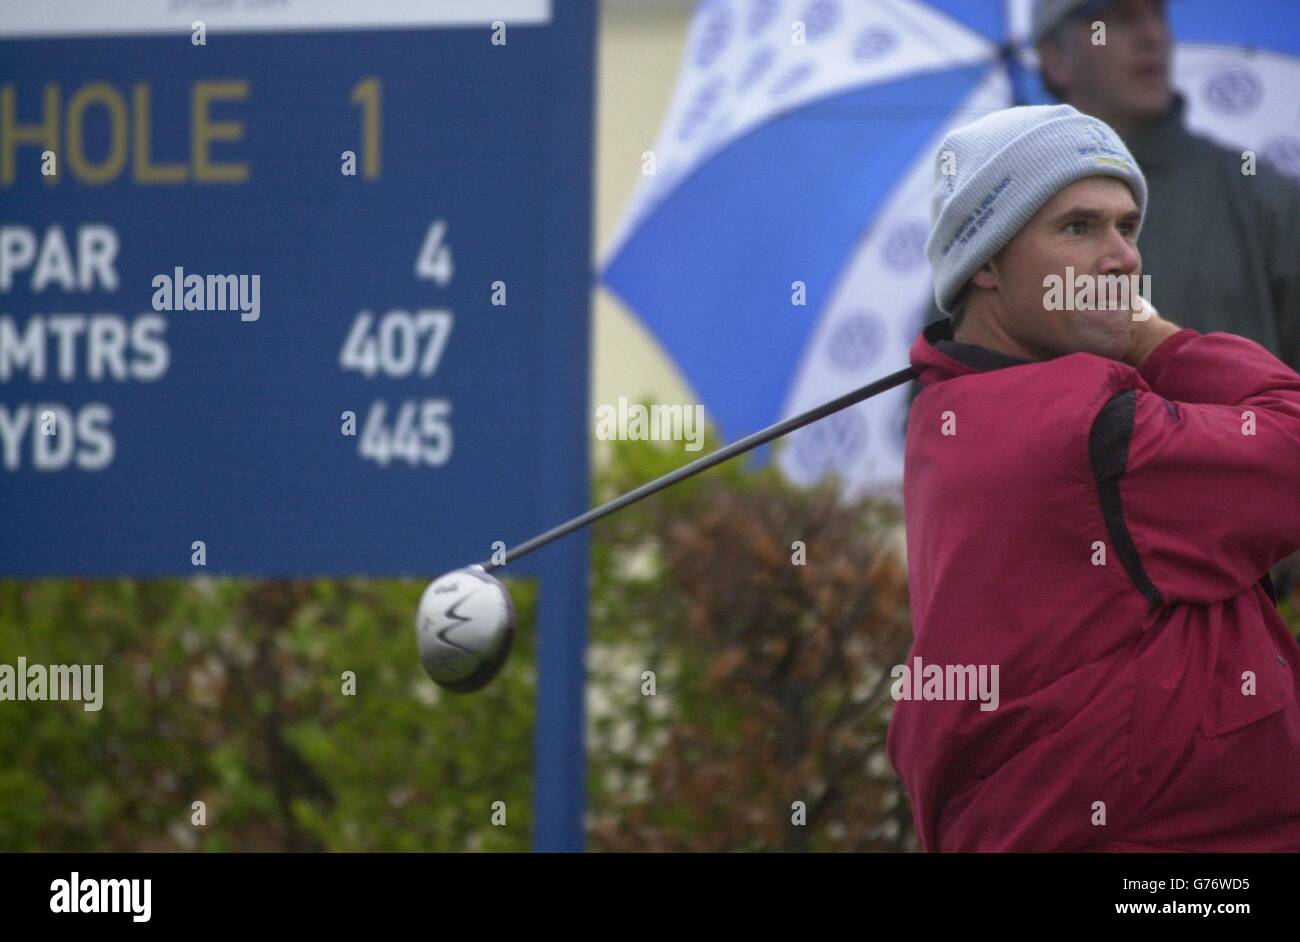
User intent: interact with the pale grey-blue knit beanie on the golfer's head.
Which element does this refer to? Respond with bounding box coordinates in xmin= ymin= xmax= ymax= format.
xmin=926 ymin=105 xmax=1147 ymax=314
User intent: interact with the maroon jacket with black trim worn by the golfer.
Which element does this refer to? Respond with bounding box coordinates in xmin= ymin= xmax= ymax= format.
xmin=887 ymin=320 xmax=1300 ymax=851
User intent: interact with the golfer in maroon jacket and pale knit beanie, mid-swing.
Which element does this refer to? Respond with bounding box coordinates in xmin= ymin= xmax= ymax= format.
xmin=888 ymin=105 xmax=1300 ymax=851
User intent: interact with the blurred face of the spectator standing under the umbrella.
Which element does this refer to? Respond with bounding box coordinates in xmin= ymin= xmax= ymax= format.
xmin=1039 ymin=0 xmax=1173 ymax=126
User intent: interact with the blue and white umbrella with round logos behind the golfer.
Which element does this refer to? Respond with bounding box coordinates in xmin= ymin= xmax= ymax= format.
xmin=602 ymin=0 xmax=1300 ymax=499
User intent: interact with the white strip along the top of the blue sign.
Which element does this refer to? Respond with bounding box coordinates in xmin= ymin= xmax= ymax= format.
xmin=0 ymin=0 xmax=551 ymax=39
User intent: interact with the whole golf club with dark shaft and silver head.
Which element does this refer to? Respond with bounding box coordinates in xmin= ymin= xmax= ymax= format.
xmin=416 ymin=366 xmax=917 ymax=693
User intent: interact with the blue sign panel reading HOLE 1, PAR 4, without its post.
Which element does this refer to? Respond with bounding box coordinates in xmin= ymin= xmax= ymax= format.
xmin=0 ymin=0 xmax=594 ymax=576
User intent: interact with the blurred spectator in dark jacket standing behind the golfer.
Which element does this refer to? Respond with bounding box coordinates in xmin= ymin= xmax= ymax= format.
xmin=1032 ymin=0 xmax=1300 ymax=370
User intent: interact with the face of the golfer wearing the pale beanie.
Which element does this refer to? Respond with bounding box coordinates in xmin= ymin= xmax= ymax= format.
xmin=971 ymin=177 xmax=1141 ymax=360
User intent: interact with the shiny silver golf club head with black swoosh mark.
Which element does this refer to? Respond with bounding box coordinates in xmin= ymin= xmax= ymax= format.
xmin=415 ymin=565 xmax=515 ymax=694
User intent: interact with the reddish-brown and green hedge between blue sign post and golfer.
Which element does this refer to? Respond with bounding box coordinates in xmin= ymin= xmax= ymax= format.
xmin=589 ymin=428 xmax=915 ymax=851
